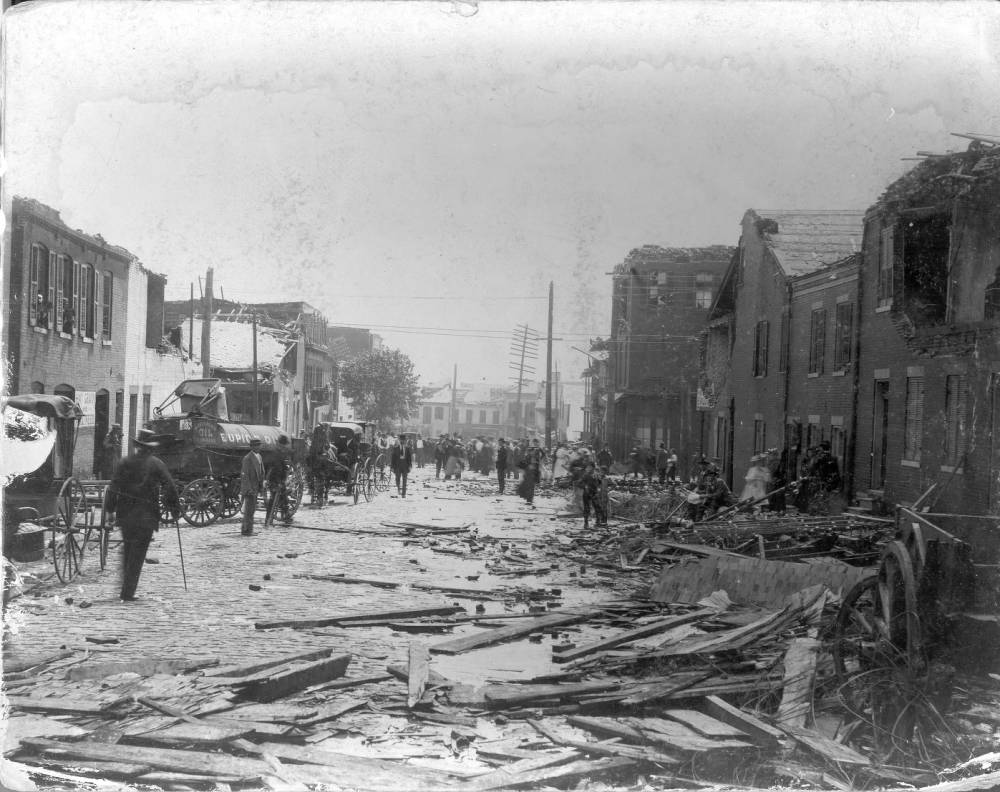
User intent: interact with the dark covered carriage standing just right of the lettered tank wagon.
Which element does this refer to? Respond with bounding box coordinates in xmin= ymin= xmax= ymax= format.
xmin=309 ymin=421 xmax=389 ymax=506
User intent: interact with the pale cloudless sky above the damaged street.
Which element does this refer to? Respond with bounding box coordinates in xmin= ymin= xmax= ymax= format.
xmin=3 ymin=0 xmax=1000 ymax=384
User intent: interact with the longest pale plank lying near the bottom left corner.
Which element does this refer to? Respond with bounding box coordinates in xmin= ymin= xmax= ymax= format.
xmin=23 ymin=739 xmax=272 ymax=779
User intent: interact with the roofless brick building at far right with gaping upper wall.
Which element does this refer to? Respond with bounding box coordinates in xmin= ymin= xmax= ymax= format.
xmin=855 ymin=139 xmax=1000 ymax=514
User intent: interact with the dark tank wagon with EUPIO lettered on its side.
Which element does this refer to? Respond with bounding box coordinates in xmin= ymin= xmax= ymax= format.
xmin=145 ymin=379 xmax=306 ymax=526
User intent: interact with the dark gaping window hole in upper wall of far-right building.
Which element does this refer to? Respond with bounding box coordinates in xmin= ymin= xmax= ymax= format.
xmin=900 ymin=214 xmax=951 ymax=324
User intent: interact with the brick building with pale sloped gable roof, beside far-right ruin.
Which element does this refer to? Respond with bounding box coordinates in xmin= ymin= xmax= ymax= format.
xmin=692 ymin=209 xmax=864 ymax=494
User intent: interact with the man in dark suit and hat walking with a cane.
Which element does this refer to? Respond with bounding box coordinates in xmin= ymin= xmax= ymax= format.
xmin=104 ymin=429 xmax=180 ymax=602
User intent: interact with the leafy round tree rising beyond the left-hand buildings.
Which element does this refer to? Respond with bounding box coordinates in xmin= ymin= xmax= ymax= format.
xmin=340 ymin=348 xmax=420 ymax=427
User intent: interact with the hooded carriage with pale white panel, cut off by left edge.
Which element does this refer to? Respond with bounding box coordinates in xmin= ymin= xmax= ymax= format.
xmin=3 ymin=394 xmax=110 ymax=583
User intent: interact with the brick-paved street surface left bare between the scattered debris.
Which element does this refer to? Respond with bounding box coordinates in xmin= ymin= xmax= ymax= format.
xmin=5 ymin=468 xmax=600 ymax=676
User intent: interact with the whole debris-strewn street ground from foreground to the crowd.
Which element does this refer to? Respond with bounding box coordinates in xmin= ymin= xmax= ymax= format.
xmin=3 ymin=468 xmax=1000 ymax=792
